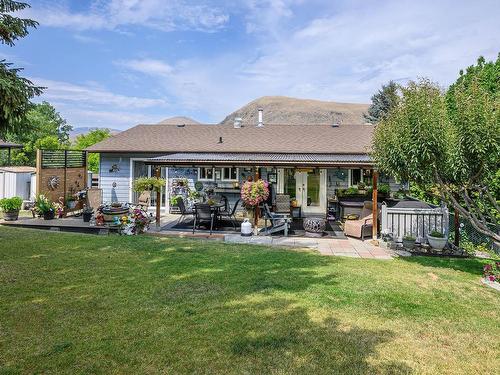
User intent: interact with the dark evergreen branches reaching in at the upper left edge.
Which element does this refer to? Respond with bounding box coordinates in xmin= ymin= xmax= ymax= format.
xmin=0 ymin=0 xmax=43 ymax=136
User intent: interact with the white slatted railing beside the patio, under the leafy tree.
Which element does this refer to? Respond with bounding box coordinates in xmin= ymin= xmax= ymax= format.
xmin=381 ymin=203 xmax=450 ymax=242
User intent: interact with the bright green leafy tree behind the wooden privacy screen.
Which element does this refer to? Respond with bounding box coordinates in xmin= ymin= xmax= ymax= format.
xmin=2 ymin=102 xmax=73 ymax=165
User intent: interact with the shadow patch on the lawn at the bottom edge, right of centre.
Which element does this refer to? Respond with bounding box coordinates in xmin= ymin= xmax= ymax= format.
xmin=226 ymin=299 xmax=412 ymax=374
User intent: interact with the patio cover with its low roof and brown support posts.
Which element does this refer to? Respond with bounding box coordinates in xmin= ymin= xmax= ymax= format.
xmin=146 ymin=153 xmax=378 ymax=240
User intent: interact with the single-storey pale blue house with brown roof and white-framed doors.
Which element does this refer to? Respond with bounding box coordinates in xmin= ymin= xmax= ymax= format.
xmin=87 ymin=109 xmax=399 ymax=215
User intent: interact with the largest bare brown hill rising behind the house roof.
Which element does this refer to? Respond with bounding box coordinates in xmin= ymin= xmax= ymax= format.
xmin=221 ymin=96 xmax=369 ymax=125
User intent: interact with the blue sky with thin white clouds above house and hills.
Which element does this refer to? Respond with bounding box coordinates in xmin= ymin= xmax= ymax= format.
xmin=0 ymin=0 xmax=500 ymax=129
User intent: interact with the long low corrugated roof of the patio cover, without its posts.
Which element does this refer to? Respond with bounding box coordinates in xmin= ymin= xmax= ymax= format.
xmin=146 ymin=152 xmax=373 ymax=167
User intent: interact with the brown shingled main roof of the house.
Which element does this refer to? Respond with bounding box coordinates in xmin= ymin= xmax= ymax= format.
xmin=87 ymin=124 xmax=374 ymax=154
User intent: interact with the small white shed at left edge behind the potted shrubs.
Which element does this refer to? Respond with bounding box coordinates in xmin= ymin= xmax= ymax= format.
xmin=0 ymin=167 xmax=36 ymax=200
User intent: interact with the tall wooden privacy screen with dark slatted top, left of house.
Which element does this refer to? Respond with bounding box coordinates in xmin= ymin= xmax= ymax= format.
xmin=36 ymin=150 xmax=87 ymax=203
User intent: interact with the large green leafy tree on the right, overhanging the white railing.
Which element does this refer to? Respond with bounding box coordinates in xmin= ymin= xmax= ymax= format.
xmin=373 ymin=55 xmax=500 ymax=243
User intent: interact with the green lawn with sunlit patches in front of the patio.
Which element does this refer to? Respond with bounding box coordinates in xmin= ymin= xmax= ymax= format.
xmin=0 ymin=227 xmax=500 ymax=374
